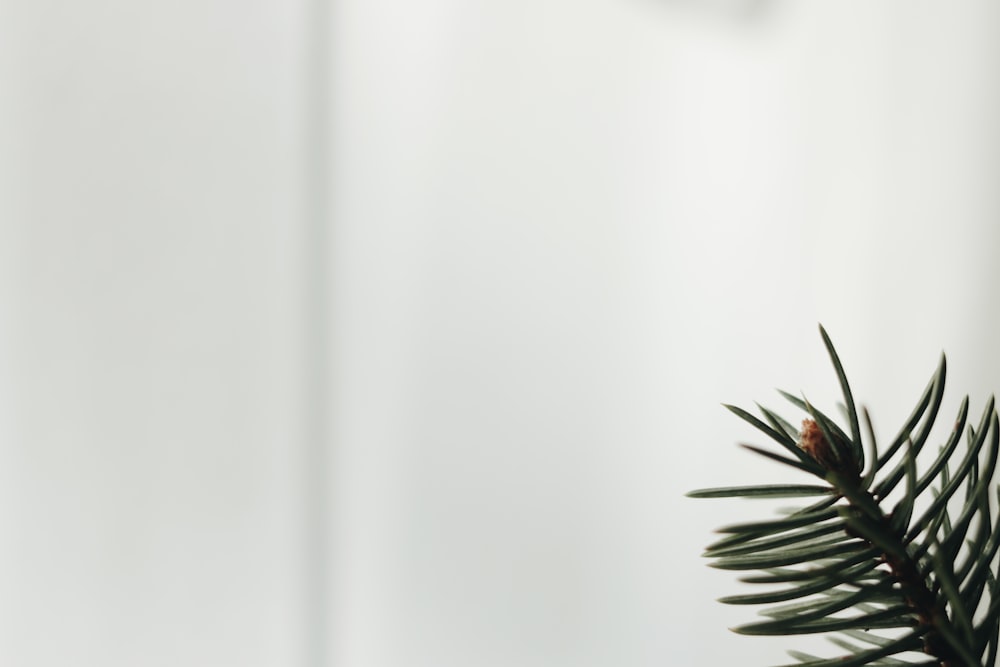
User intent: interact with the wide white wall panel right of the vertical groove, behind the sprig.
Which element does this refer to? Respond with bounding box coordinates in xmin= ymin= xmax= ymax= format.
xmin=331 ymin=0 xmax=1000 ymax=667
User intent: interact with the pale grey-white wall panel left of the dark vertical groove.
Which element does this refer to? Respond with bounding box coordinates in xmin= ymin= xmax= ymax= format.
xmin=0 ymin=0 xmax=304 ymax=667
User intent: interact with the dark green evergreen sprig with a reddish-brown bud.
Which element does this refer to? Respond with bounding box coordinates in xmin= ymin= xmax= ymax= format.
xmin=688 ymin=327 xmax=1000 ymax=667
